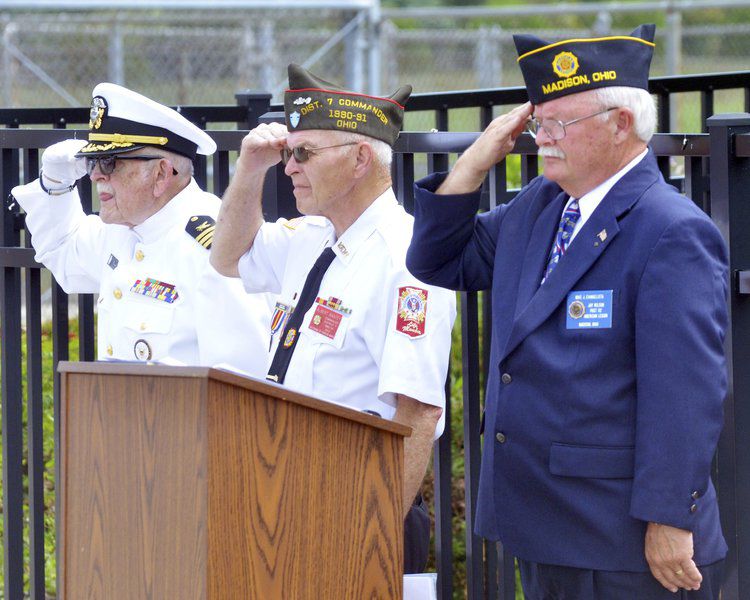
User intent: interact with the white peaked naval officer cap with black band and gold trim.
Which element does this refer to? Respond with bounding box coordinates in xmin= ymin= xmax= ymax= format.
xmin=76 ymin=83 xmax=216 ymax=159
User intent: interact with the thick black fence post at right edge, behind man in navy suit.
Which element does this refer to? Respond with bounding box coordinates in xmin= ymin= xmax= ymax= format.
xmin=707 ymin=114 xmax=750 ymax=600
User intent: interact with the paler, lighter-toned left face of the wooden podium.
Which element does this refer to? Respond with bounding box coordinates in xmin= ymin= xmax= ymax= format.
xmin=61 ymin=374 xmax=208 ymax=600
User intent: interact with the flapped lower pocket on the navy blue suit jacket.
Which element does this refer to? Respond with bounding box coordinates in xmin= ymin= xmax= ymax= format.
xmin=549 ymin=442 xmax=635 ymax=479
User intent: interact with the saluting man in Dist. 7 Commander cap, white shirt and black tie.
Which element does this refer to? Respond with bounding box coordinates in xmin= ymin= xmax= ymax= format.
xmin=211 ymin=65 xmax=456 ymax=573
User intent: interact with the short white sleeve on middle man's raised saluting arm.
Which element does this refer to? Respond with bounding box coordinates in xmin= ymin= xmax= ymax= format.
xmin=237 ymin=219 xmax=304 ymax=294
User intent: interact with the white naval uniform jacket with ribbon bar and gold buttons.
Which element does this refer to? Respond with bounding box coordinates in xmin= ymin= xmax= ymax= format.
xmin=13 ymin=180 xmax=273 ymax=378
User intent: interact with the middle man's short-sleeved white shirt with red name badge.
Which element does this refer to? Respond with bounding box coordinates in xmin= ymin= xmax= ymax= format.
xmin=239 ymin=190 xmax=456 ymax=435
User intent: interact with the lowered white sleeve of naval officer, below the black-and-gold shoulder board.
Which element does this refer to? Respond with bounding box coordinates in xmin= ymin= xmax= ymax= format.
xmin=195 ymin=255 xmax=273 ymax=379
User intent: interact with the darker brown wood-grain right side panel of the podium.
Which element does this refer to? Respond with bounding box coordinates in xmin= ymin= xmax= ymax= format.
xmin=208 ymin=382 xmax=403 ymax=600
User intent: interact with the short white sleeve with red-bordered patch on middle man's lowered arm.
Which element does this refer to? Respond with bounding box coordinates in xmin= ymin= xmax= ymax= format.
xmin=378 ymin=270 xmax=456 ymax=437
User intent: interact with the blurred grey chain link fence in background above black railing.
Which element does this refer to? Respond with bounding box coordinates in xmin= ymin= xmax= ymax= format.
xmin=0 ymin=2 xmax=750 ymax=107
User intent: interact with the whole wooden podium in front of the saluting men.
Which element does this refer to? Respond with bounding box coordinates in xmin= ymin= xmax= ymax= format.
xmin=58 ymin=362 xmax=410 ymax=600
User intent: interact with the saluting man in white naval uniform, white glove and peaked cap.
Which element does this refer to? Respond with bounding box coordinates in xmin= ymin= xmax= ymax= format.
xmin=12 ymin=83 xmax=272 ymax=377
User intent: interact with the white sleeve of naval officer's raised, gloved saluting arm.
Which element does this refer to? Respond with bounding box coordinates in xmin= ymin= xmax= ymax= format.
xmin=11 ymin=179 xmax=105 ymax=293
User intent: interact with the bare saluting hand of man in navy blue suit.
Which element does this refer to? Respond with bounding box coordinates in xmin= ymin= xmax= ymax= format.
xmin=437 ymin=102 xmax=534 ymax=194
